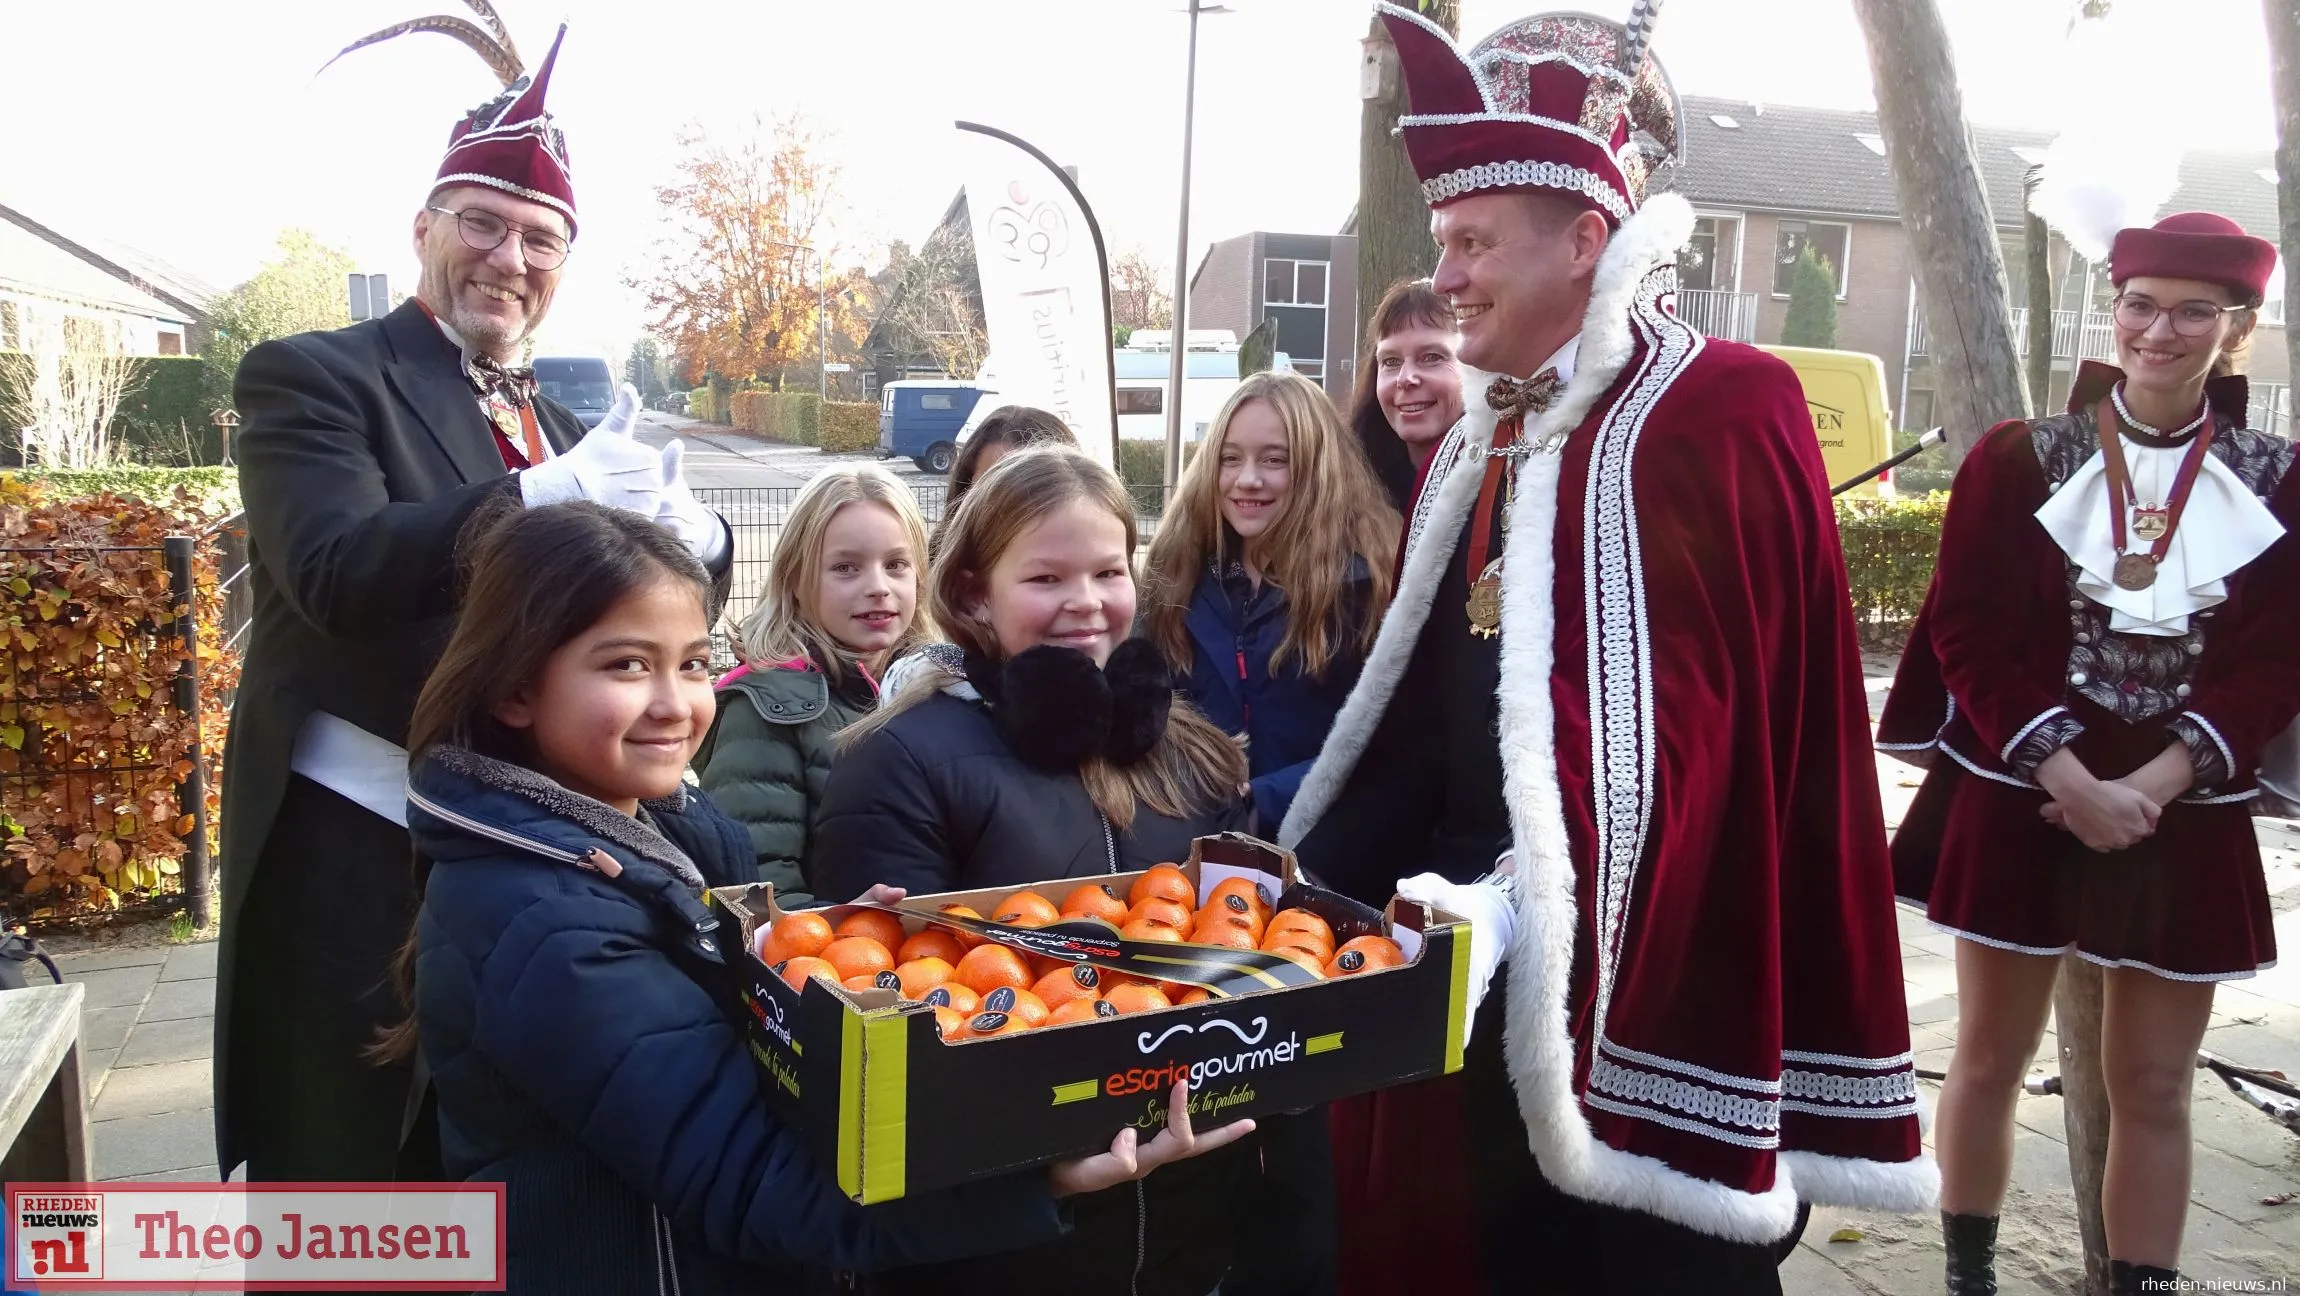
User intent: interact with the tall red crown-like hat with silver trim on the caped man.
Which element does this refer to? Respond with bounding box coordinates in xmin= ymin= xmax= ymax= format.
xmin=1375 ymin=0 xmax=1679 ymax=226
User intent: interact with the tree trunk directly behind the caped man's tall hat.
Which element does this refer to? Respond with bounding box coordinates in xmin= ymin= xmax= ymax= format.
xmin=1357 ymin=0 xmax=1461 ymax=336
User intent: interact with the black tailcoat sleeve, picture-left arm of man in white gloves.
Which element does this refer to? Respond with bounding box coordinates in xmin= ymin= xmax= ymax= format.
xmin=232 ymin=338 xmax=518 ymax=635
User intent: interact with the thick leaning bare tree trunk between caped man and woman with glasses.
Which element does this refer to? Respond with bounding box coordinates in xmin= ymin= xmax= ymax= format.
xmin=1854 ymin=0 xmax=2033 ymax=463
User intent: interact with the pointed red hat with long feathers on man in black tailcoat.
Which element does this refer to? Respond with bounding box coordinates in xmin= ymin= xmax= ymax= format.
xmin=320 ymin=0 xmax=575 ymax=232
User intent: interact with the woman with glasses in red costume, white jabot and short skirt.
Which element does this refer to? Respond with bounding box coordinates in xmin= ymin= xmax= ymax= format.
xmin=1879 ymin=212 xmax=2300 ymax=1296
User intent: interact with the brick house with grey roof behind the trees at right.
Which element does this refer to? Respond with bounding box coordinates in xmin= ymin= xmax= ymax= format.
xmin=1672 ymin=94 xmax=2291 ymax=435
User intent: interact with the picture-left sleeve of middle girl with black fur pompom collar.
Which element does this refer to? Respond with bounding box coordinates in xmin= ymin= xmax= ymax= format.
xmin=807 ymin=727 xmax=959 ymax=898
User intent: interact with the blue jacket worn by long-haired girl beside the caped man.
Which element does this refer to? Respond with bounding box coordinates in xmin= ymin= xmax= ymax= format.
xmin=1175 ymin=559 xmax=1373 ymax=833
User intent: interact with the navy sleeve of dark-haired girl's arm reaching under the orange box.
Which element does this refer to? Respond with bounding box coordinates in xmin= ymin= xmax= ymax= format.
xmin=439 ymin=882 xmax=1063 ymax=1271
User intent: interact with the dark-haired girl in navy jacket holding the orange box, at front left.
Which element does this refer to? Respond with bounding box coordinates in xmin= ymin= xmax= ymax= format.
xmin=384 ymin=504 xmax=1260 ymax=1296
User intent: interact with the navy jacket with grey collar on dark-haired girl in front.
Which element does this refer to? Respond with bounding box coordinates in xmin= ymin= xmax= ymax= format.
xmin=407 ymin=748 xmax=1063 ymax=1296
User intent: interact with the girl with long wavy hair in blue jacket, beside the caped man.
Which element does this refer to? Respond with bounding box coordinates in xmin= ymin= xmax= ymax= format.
xmin=1141 ymin=373 xmax=1398 ymax=836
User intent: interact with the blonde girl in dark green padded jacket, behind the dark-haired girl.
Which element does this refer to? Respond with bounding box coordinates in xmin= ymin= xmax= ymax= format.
xmin=695 ymin=465 xmax=934 ymax=905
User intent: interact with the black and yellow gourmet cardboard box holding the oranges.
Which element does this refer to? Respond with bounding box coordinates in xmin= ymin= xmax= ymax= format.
xmin=708 ymin=833 xmax=1470 ymax=1202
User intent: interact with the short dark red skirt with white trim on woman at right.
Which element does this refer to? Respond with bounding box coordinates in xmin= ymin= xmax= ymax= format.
xmin=1902 ymin=697 xmax=2277 ymax=981
